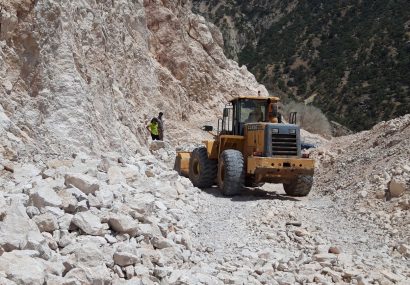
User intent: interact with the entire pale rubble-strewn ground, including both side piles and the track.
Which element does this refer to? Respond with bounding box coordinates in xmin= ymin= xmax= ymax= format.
xmin=0 ymin=116 xmax=410 ymax=284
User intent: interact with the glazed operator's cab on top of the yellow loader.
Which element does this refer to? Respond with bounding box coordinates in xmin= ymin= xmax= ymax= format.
xmin=220 ymin=97 xmax=280 ymax=136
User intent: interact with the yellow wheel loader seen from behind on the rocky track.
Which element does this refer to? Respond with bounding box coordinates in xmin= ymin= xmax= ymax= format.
xmin=175 ymin=96 xmax=314 ymax=196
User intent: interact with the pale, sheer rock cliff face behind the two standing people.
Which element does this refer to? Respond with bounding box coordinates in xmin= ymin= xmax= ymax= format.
xmin=0 ymin=0 xmax=266 ymax=160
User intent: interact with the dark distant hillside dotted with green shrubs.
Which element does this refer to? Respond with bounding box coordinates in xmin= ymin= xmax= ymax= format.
xmin=193 ymin=0 xmax=410 ymax=130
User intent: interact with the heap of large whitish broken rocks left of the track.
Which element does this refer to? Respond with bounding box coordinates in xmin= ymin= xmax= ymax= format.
xmin=0 ymin=146 xmax=212 ymax=285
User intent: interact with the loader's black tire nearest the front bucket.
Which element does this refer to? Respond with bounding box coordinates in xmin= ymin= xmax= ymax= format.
xmin=189 ymin=147 xmax=217 ymax=188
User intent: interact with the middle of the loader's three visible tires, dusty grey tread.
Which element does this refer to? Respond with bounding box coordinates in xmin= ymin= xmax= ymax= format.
xmin=218 ymin=149 xmax=245 ymax=196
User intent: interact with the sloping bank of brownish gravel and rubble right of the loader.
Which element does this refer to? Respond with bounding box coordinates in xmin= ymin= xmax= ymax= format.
xmin=314 ymin=115 xmax=410 ymax=284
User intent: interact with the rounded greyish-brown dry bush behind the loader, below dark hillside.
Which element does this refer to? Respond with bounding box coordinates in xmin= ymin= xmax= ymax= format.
xmin=282 ymin=102 xmax=332 ymax=138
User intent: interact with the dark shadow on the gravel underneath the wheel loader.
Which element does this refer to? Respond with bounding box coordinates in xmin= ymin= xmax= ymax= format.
xmin=202 ymin=186 xmax=300 ymax=202
